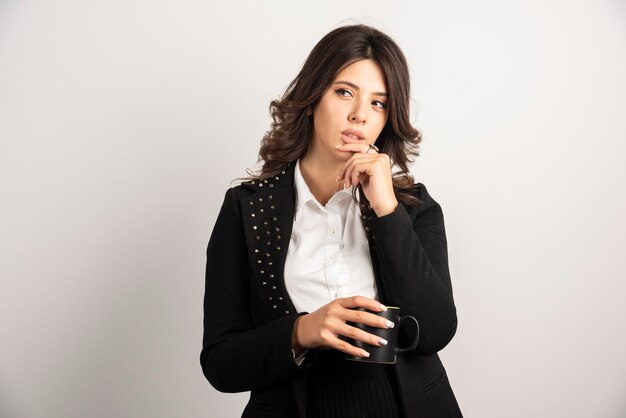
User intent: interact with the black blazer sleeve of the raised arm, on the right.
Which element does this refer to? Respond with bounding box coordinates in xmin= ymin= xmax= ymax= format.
xmin=368 ymin=184 xmax=457 ymax=355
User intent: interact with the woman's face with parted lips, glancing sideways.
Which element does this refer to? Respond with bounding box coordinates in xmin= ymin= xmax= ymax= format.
xmin=307 ymin=59 xmax=388 ymax=162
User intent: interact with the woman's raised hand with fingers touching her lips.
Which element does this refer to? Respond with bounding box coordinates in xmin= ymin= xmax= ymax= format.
xmin=337 ymin=144 xmax=398 ymax=216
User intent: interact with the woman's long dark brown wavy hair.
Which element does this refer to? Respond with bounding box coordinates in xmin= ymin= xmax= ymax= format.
xmin=252 ymin=25 xmax=422 ymax=205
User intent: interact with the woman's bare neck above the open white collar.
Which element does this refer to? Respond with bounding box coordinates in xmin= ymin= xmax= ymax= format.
xmin=300 ymin=154 xmax=343 ymax=205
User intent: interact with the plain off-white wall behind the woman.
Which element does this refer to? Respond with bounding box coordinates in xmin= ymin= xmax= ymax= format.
xmin=0 ymin=0 xmax=626 ymax=418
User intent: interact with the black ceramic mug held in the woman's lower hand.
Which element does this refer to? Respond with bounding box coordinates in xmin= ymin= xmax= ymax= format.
xmin=346 ymin=306 xmax=419 ymax=364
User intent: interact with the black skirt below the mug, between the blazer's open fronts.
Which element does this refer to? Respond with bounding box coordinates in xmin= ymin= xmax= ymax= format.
xmin=307 ymin=350 xmax=403 ymax=418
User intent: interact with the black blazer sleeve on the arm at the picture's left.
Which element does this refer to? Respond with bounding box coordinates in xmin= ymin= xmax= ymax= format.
xmin=200 ymin=189 xmax=299 ymax=392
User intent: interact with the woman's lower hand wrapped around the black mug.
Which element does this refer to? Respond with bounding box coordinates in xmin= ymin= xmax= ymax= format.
xmin=291 ymin=296 xmax=394 ymax=357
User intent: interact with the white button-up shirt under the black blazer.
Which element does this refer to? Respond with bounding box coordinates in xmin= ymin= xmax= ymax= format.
xmin=285 ymin=161 xmax=378 ymax=312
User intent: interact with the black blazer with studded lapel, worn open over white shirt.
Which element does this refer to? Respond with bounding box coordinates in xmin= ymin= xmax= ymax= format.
xmin=200 ymin=164 xmax=462 ymax=418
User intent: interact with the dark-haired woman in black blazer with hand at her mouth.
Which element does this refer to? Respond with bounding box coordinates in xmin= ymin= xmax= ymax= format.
xmin=201 ymin=25 xmax=461 ymax=418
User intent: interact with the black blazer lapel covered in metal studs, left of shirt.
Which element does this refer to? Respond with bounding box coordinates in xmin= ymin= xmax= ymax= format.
xmin=241 ymin=164 xmax=296 ymax=319
